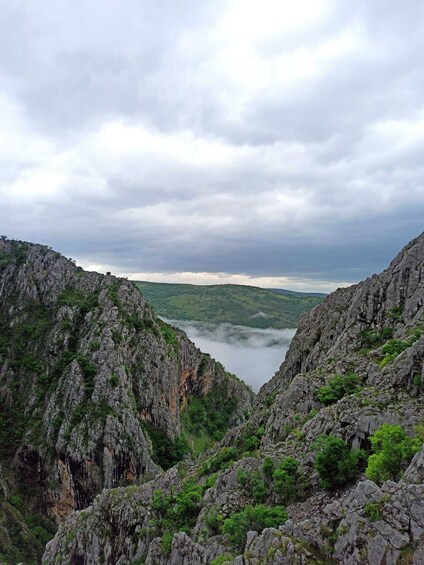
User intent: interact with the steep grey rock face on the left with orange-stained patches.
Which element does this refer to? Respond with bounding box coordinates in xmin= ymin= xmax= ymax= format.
xmin=0 ymin=238 xmax=253 ymax=561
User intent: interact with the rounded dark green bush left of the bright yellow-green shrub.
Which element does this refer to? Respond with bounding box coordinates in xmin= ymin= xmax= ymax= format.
xmin=313 ymin=436 xmax=367 ymax=489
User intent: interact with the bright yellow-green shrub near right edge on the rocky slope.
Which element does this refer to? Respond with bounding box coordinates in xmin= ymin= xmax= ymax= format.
xmin=365 ymin=424 xmax=422 ymax=483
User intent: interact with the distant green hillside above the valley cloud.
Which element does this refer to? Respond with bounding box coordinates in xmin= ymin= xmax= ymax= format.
xmin=135 ymin=282 xmax=325 ymax=329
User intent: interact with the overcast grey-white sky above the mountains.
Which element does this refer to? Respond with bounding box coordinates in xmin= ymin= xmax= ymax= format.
xmin=0 ymin=0 xmax=424 ymax=291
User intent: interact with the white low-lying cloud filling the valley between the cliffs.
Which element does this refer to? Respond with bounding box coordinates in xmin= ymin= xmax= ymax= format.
xmin=165 ymin=320 xmax=296 ymax=392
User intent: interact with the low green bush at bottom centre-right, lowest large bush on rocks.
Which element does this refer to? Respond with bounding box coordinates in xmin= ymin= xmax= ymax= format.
xmin=222 ymin=504 xmax=288 ymax=547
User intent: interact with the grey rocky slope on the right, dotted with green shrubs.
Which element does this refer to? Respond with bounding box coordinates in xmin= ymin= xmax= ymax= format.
xmin=44 ymin=234 xmax=424 ymax=565
